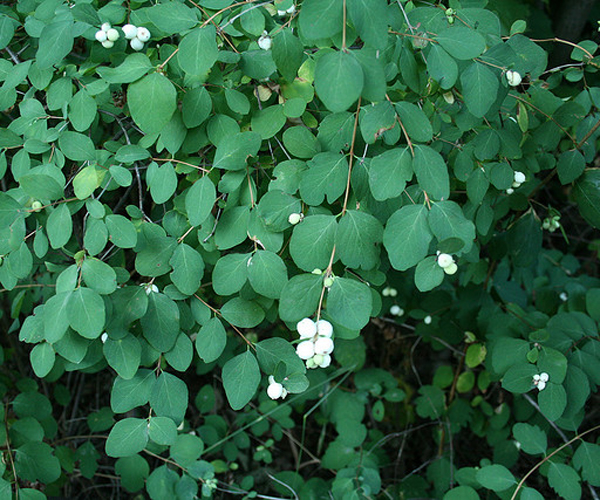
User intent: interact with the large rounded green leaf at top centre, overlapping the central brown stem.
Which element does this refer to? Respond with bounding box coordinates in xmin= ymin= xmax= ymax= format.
xmin=314 ymin=51 xmax=364 ymax=113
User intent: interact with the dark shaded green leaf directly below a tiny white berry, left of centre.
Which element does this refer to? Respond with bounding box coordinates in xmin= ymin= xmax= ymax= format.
xmin=140 ymin=293 xmax=179 ymax=352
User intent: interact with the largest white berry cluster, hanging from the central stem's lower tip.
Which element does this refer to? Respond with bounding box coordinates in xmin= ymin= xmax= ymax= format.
xmin=296 ymin=318 xmax=334 ymax=368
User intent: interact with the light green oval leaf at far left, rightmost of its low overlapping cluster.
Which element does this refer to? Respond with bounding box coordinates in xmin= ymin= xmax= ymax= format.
xmin=67 ymin=287 xmax=106 ymax=339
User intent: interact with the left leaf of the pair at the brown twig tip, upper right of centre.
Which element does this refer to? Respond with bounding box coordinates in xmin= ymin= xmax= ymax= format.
xmin=369 ymin=148 xmax=413 ymax=201
